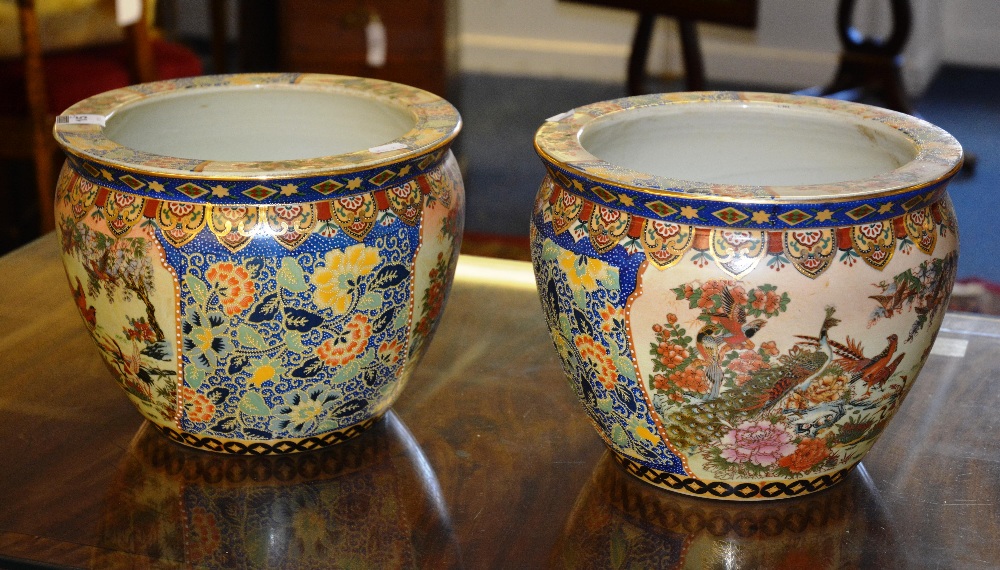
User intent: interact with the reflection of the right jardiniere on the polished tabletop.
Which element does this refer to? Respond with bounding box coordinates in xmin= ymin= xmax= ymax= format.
xmin=552 ymin=454 xmax=898 ymax=569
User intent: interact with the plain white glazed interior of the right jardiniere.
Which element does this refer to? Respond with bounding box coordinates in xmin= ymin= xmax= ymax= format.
xmin=579 ymin=104 xmax=918 ymax=186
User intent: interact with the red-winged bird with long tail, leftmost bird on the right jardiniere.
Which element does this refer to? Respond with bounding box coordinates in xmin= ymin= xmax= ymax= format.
xmin=695 ymin=288 xmax=766 ymax=400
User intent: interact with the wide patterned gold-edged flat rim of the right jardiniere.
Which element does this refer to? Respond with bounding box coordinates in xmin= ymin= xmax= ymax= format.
xmin=534 ymin=91 xmax=963 ymax=203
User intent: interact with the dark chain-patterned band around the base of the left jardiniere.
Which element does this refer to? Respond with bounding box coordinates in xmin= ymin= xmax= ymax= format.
xmin=153 ymin=415 xmax=382 ymax=455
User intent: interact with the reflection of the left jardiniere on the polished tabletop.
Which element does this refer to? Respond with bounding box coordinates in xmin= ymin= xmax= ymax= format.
xmin=91 ymin=411 xmax=458 ymax=568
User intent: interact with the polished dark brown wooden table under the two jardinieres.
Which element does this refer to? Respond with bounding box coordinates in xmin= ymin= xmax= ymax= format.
xmin=0 ymin=235 xmax=1000 ymax=568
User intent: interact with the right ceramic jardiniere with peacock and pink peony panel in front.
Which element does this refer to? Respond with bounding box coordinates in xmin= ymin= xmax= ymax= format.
xmin=532 ymin=93 xmax=962 ymax=499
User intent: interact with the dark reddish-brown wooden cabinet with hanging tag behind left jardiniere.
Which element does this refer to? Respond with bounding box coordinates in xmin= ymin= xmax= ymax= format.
xmin=274 ymin=0 xmax=451 ymax=96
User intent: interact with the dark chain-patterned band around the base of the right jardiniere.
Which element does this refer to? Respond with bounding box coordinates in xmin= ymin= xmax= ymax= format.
xmin=611 ymin=452 xmax=855 ymax=501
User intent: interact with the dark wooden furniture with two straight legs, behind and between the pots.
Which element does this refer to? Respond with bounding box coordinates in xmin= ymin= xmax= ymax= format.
xmin=560 ymin=0 xmax=757 ymax=95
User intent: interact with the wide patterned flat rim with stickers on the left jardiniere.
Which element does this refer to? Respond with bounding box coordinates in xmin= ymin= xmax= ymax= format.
xmin=53 ymin=73 xmax=462 ymax=180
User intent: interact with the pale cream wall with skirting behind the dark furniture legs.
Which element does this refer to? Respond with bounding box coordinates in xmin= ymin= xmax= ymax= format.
xmin=457 ymin=0 xmax=1000 ymax=94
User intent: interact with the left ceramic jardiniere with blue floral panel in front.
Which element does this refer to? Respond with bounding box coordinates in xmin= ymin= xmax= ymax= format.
xmin=55 ymin=74 xmax=464 ymax=454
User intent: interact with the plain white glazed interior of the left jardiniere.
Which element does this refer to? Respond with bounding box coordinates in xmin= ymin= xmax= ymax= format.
xmin=104 ymin=86 xmax=416 ymax=162
